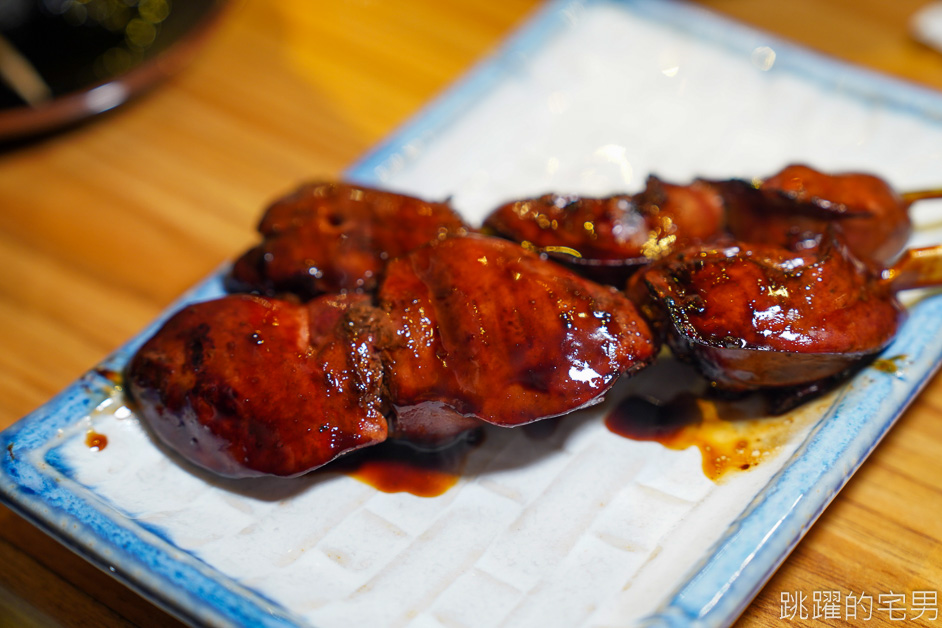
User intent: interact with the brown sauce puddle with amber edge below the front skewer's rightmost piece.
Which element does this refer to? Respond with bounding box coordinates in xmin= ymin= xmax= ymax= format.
xmin=605 ymin=393 xmax=816 ymax=481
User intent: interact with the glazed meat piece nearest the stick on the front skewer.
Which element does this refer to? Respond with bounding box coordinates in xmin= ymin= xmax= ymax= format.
xmin=629 ymin=234 xmax=904 ymax=391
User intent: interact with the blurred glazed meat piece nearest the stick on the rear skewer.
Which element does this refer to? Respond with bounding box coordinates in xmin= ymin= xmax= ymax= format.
xmin=714 ymin=164 xmax=912 ymax=266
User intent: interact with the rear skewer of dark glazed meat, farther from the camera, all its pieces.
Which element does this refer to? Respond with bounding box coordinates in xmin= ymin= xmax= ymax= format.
xmin=226 ymin=165 xmax=942 ymax=300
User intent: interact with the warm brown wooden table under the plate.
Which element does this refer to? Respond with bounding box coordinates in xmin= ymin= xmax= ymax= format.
xmin=0 ymin=0 xmax=942 ymax=626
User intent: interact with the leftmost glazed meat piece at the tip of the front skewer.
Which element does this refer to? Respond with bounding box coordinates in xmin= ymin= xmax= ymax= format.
xmin=126 ymin=295 xmax=387 ymax=477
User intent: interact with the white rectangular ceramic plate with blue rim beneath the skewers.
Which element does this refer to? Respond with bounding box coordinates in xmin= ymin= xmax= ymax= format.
xmin=0 ymin=0 xmax=942 ymax=628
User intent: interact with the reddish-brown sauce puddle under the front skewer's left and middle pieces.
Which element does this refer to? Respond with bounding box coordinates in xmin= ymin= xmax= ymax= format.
xmin=331 ymin=441 xmax=475 ymax=497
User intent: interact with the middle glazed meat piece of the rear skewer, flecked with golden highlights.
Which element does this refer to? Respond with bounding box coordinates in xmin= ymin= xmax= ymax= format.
xmin=484 ymin=176 xmax=723 ymax=284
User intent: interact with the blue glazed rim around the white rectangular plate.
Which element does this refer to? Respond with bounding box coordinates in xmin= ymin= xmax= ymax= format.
xmin=0 ymin=0 xmax=942 ymax=626
